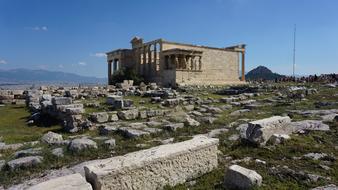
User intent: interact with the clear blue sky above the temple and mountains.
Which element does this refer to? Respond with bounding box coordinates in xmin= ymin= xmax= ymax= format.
xmin=0 ymin=0 xmax=338 ymax=77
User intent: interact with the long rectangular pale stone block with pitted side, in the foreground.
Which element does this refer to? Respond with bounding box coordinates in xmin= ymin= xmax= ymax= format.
xmin=84 ymin=135 xmax=218 ymax=190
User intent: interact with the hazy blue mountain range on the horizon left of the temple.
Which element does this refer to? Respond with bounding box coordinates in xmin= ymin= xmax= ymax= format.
xmin=0 ymin=69 xmax=107 ymax=84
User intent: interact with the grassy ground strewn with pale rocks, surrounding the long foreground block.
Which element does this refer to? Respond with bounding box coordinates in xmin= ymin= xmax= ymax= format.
xmin=0 ymin=81 xmax=338 ymax=189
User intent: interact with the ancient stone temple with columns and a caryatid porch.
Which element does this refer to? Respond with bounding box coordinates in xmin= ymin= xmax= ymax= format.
xmin=107 ymin=37 xmax=245 ymax=86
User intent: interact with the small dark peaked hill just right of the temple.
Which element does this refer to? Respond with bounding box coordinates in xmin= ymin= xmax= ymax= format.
xmin=245 ymin=66 xmax=285 ymax=80
